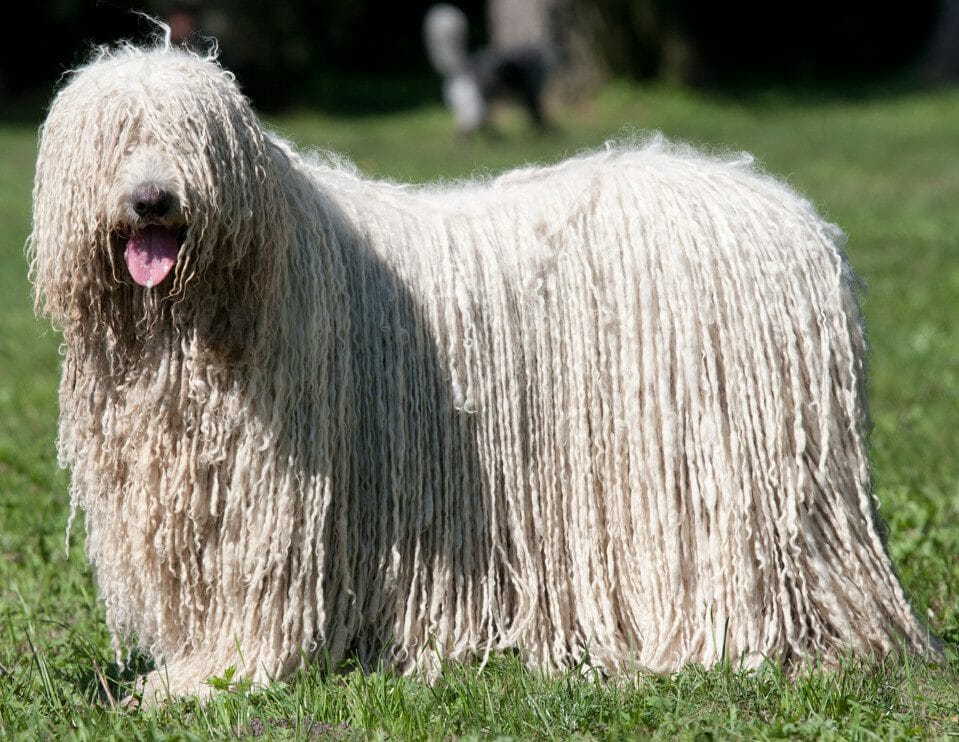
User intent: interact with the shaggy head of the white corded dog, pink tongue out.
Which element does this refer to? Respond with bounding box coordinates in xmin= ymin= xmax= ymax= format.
xmin=28 ymin=44 xmax=285 ymax=360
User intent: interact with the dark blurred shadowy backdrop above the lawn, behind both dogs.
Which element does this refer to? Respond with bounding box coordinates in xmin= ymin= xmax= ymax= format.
xmin=0 ymin=0 xmax=959 ymax=112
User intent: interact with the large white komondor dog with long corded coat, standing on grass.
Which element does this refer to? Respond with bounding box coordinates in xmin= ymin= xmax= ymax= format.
xmin=29 ymin=37 xmax=928 ymax=708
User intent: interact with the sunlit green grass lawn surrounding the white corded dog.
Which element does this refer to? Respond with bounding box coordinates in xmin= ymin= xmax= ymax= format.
xmin=0 ymin=85 xmax=959 ymax=739
